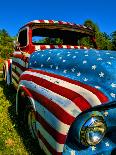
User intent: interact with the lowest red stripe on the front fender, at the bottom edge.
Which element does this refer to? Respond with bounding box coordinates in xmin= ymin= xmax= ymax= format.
xmin=38 ymin=132 xmax=62 ymax=155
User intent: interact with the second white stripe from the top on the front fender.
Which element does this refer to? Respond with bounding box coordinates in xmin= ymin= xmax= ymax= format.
xmin=21 ymin=80 xmax=81 ymax=117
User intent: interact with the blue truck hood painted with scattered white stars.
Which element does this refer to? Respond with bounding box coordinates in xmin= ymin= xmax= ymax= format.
xmin=29 ymin=49 xmax=116 ymax=101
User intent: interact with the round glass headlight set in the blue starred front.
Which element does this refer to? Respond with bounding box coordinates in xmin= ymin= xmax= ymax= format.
xmin=80 ymin=116 xmax=106 ymax=146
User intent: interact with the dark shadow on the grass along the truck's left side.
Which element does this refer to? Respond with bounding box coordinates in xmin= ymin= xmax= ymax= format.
xmin=0 ymin=81 xmax=45 ymax=155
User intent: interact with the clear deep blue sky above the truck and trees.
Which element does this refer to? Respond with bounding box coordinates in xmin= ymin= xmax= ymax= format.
xmin=0 ymin=0 xmax=116 ymax=36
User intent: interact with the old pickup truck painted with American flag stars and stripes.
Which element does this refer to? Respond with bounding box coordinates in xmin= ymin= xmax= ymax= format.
xmin=3 ymin=20 xmax=116 ymax=155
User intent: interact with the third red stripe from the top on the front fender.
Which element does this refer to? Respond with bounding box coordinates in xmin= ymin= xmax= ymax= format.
xmin=23 ymin=87 xmax=75 ymax=125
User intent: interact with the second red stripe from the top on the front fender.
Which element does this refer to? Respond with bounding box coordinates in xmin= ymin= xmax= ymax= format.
xmin=20 ymin=74 xmax=91 ymax=111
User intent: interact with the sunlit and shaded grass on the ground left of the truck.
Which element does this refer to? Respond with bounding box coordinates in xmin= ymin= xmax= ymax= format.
xmin=0 ymin=81 xmax=44 ymax=155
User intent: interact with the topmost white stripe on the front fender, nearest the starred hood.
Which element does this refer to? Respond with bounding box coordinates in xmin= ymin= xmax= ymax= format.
xmin=24 ymin=71 xmax=101 ymax=106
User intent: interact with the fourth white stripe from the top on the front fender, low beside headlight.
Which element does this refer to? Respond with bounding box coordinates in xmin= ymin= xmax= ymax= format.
xmin=36 ymin=122 xmax=64 ymax=152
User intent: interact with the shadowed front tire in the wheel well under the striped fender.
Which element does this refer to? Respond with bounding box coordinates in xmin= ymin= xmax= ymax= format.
xmin=18 ymin=97 xmax=37 ymax=140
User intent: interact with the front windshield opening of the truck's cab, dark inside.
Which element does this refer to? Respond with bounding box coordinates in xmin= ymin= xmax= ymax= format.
xmin=32 ymin=28 xmax=94 ymax=47
